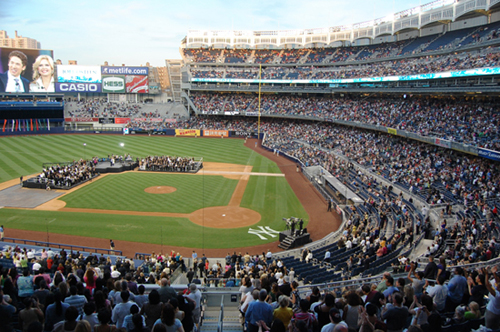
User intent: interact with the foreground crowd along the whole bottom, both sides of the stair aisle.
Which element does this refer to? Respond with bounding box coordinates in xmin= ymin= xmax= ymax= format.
xmin=0 ymin=235 xmax=500 ymax=332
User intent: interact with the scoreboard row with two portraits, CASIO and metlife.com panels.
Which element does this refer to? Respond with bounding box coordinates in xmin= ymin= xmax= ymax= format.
xmin=0 ymin=48 xmax=149 ymax=94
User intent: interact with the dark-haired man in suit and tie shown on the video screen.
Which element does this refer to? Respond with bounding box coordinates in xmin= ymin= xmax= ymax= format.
xmin=0 ymin=51 xmax=30 ymax=93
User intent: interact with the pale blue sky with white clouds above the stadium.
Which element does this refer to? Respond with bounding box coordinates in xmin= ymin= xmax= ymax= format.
xmin=0 ymin=0 xmax=422 ymax=66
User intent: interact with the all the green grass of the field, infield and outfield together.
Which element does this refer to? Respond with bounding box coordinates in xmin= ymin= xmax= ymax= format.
xmin=0 ymin=135 xmax=308 ymax=248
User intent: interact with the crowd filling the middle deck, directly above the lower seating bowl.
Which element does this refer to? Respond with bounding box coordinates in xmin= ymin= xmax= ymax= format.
xmin=188 ymin=93 xmax=500 ymax=150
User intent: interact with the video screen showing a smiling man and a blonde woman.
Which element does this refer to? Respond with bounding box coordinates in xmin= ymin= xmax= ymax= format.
xmin=0 ymin=47 xmax=55 ymax=93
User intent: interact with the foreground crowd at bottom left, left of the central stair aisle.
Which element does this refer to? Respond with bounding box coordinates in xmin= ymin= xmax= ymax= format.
xmin=0 ymin=246 xmax=201 ymax=332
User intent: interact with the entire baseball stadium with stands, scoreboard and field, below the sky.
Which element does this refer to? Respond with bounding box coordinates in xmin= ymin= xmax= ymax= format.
xmin=0 ymin=0 xmax=500 ymax=332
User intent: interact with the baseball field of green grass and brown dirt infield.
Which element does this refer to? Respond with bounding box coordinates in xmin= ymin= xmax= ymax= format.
xmin=0 ymin=135 xmax=320 ymax=254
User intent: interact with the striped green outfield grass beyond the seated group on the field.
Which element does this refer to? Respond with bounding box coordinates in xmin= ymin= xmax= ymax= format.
xmin=0 ymin=135 xmax=280 ymax=182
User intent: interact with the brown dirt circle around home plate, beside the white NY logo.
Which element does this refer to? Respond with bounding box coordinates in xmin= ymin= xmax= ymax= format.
xmin=189 ymin=206 xmax=261 ymax=228
